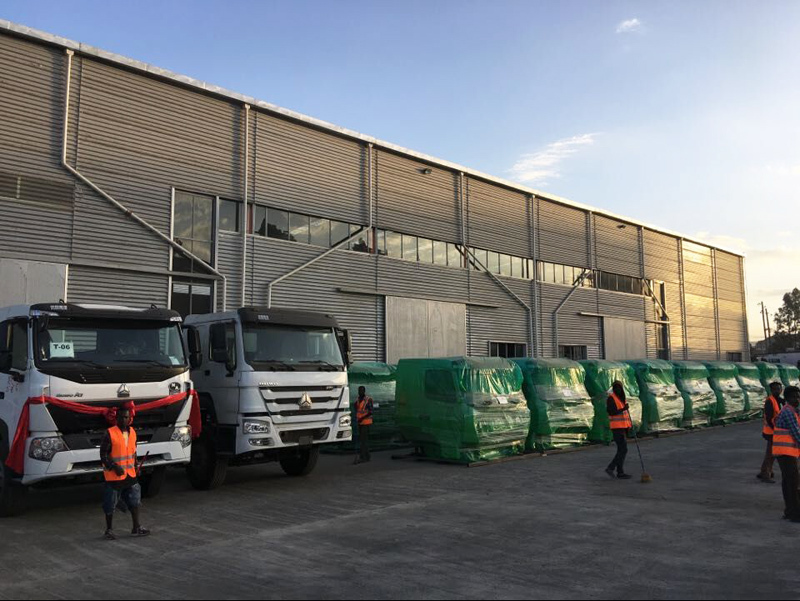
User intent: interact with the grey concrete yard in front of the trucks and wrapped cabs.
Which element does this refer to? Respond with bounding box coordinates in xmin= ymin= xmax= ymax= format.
xmin=0 ymin=423 xmax=800 ymax=600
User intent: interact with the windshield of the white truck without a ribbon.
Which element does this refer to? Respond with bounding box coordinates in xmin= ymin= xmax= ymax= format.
xmin=244 ymin=324 xmax=344 ymax=371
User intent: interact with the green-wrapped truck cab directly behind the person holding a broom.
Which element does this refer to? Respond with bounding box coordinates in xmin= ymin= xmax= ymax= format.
xmin=580 ymin=361 xmax=642 ymax=443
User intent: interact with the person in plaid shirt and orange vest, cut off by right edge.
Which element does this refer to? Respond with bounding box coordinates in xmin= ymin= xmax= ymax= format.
xmin=772 ymin=386 xmax=800 ymax=523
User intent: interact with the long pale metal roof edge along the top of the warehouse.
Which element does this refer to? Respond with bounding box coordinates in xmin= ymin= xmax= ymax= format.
xmin=0 ymin=19 xmax=744 ymax=257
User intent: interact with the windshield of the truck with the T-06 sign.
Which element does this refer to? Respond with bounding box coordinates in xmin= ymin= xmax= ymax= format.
xmin=36 ymin=318 xmax=186 ymax=368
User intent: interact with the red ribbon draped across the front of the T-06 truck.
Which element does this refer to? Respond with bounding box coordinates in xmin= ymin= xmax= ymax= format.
xmin=6 ymin=390 xmax=203 ymax=475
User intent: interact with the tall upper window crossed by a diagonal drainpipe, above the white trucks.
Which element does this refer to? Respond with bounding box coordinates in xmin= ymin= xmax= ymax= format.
xmin=172 ymin=191 xmax=214 ymax=272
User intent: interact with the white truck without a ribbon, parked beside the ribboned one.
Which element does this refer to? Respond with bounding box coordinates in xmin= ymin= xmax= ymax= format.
xmin=186 ymin=307 xmax=352 ymax=489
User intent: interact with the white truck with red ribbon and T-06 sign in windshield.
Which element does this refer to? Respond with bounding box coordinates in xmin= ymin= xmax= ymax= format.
xmin=0 ymin=302 xmax=192 ymax=515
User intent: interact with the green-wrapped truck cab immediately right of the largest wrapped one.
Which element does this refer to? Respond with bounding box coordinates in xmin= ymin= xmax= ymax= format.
xmin=514 ymin=359 xmax=594 ymax=451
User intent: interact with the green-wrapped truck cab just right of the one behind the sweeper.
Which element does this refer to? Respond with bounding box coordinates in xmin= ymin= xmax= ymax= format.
xmin=626 ymin=359 xmax=684 ymax=433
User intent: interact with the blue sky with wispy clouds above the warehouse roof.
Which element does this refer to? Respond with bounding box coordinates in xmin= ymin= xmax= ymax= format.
xmin=0 ymin=0 xmax=800 ymax=340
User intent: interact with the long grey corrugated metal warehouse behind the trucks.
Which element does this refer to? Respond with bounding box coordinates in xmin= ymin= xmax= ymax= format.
xmin=0 ymin=20 xmax=749 ymax=362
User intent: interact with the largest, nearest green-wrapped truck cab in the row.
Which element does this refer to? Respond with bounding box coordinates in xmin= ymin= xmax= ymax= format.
xmin=397 ymin=357 xmax=531 ymax=463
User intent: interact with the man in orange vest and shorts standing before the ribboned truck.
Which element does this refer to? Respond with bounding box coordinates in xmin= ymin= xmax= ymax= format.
xmin=100 ymin=402 xmax=150 ymax=540
